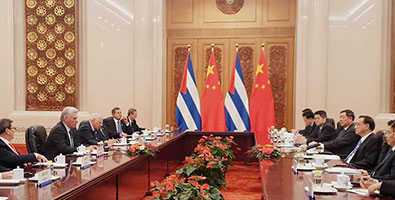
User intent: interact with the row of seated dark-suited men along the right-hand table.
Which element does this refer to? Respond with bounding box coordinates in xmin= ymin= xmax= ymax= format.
xmin=296 ymin=109 xmax=395 ymax=197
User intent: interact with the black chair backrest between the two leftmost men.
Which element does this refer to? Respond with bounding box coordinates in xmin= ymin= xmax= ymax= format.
xmin=25 ymin=125 xmax=47 ymax=154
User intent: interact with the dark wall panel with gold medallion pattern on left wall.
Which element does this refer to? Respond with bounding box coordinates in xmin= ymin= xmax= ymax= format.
xmin=25 ymin=0 xmax=78 ymax=110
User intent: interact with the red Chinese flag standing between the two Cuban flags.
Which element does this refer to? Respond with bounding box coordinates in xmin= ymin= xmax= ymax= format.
xmin=200 ymin=51 xmax=226 ymax=131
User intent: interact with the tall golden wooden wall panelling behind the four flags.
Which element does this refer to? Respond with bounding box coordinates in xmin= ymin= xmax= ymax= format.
xmin=166 ymin=0 xmax=296 ymax=129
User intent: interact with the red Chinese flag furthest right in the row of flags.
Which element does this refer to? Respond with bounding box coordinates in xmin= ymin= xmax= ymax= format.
xmin=250 ymin=48 xmax=276 ymax=144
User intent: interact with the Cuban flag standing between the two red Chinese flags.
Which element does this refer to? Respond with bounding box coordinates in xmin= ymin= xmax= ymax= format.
xmin=225 ymin=49 xmax=250 ymax=131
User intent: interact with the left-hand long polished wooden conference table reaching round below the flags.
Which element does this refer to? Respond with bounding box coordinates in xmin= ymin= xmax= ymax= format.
xmin=0 ymin=132 xmax=255 ymax=200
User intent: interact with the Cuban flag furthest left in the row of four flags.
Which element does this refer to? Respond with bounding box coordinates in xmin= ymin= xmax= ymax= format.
xmin=176 ymin=49 xmax=202 ymax=132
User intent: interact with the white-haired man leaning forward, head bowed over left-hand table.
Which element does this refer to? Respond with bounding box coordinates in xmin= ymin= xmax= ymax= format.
xmin=77 ymin=113 xmax=114 ymax=146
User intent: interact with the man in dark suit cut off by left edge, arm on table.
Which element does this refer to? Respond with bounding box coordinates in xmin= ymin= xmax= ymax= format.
xmin=0 ymin=119 xmax=47 ymax=171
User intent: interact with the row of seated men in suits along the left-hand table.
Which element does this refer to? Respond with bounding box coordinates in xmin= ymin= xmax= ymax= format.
xmin=0 ymin=107 xmax=144 ymax=179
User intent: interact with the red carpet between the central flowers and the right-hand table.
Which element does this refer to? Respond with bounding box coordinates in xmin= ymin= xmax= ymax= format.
xmin=143 ymin=163 xmax=262 ymax=200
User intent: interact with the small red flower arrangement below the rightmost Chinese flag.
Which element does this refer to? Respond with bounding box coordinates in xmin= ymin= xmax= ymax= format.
xmin=247 ymin=144 xmax=283 ymax=160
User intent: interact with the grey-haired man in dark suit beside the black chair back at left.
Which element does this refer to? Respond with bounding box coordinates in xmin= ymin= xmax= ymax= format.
xmin=45 ymin=107 xmax=94 ymax=159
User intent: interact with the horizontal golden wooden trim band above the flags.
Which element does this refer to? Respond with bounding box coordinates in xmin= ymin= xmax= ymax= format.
xmin=167 ymin=26 xmax=295 ymax=38
